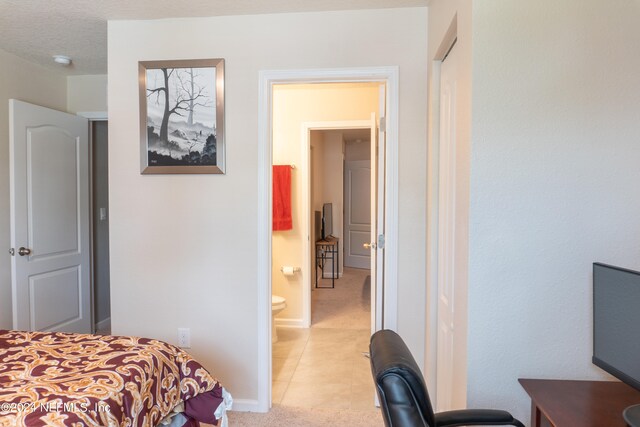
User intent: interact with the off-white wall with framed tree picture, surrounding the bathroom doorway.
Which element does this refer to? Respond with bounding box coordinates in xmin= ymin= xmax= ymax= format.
xmin=108 ymin=8 xmax=426 ymax=408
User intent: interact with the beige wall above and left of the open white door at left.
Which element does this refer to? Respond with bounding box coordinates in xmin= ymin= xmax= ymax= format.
xmin=0 ymin=50 xmax=67 ymax=329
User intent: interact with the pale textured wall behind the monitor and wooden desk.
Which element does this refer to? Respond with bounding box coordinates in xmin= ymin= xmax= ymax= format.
xmin=468 ymin=0 xmax=640 ymax=420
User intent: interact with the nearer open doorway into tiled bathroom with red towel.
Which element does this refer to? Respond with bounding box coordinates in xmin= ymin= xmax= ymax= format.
xmin=271 ymin=82 xmax=385 ymax=411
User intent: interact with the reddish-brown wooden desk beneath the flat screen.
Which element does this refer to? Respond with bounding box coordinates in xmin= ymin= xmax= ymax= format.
xmin=518 ymin=378 xmax=640 ymax=427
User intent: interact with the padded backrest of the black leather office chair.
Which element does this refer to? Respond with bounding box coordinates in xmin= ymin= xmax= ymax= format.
xmin=369 ymin=329 xmax=435 ymax=427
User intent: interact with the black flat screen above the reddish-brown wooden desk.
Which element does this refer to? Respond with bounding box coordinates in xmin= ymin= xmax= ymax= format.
xmin=592 ymin=263 xmax=640 ymax=394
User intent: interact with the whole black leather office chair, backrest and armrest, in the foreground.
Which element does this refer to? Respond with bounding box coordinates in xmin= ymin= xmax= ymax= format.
xmin=369 ymin=329 xmax=524 ymax=427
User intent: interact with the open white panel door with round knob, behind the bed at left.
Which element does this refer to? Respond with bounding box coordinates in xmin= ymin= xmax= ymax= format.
xmin=9 ymin=99 xmax=92 ymax=333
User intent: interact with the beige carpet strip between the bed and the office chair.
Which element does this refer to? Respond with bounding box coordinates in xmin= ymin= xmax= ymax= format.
xmin=229 ymin=405 xmax=384 ymax=427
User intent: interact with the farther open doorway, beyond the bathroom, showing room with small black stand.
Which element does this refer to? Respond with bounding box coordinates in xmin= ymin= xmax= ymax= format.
xmin=309 ymin=128 xmax=371 ymax=332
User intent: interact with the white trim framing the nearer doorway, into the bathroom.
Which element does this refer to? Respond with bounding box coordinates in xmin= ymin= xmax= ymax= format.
xmin=256 ymin=66 xmax=399 ymax=412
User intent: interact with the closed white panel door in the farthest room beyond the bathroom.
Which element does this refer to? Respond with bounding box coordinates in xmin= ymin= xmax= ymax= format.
xmin=344 ymin=160 xmax=371 ymax=269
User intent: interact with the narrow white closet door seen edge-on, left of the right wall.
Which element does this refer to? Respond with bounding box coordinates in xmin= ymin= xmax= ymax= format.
xmin=436 ymin=43 xmax=459 ymax=411
